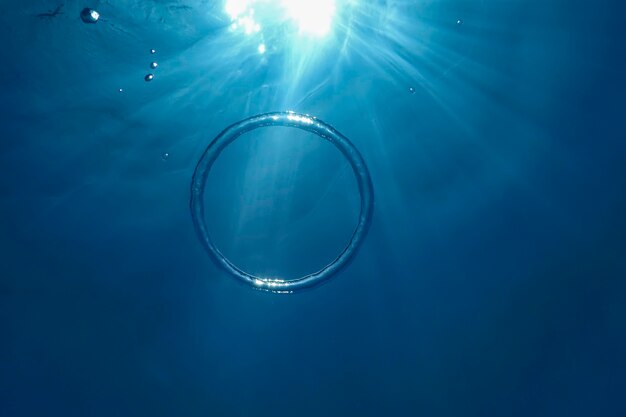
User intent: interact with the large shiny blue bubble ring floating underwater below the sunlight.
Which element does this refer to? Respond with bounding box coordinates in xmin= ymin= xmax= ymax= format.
xmin=190 ymin=112 xmax=374 ymax=293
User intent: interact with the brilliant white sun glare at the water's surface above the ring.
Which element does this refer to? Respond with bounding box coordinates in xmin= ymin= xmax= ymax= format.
xmin=224 ymin=0 xmax=335 ymax=36
